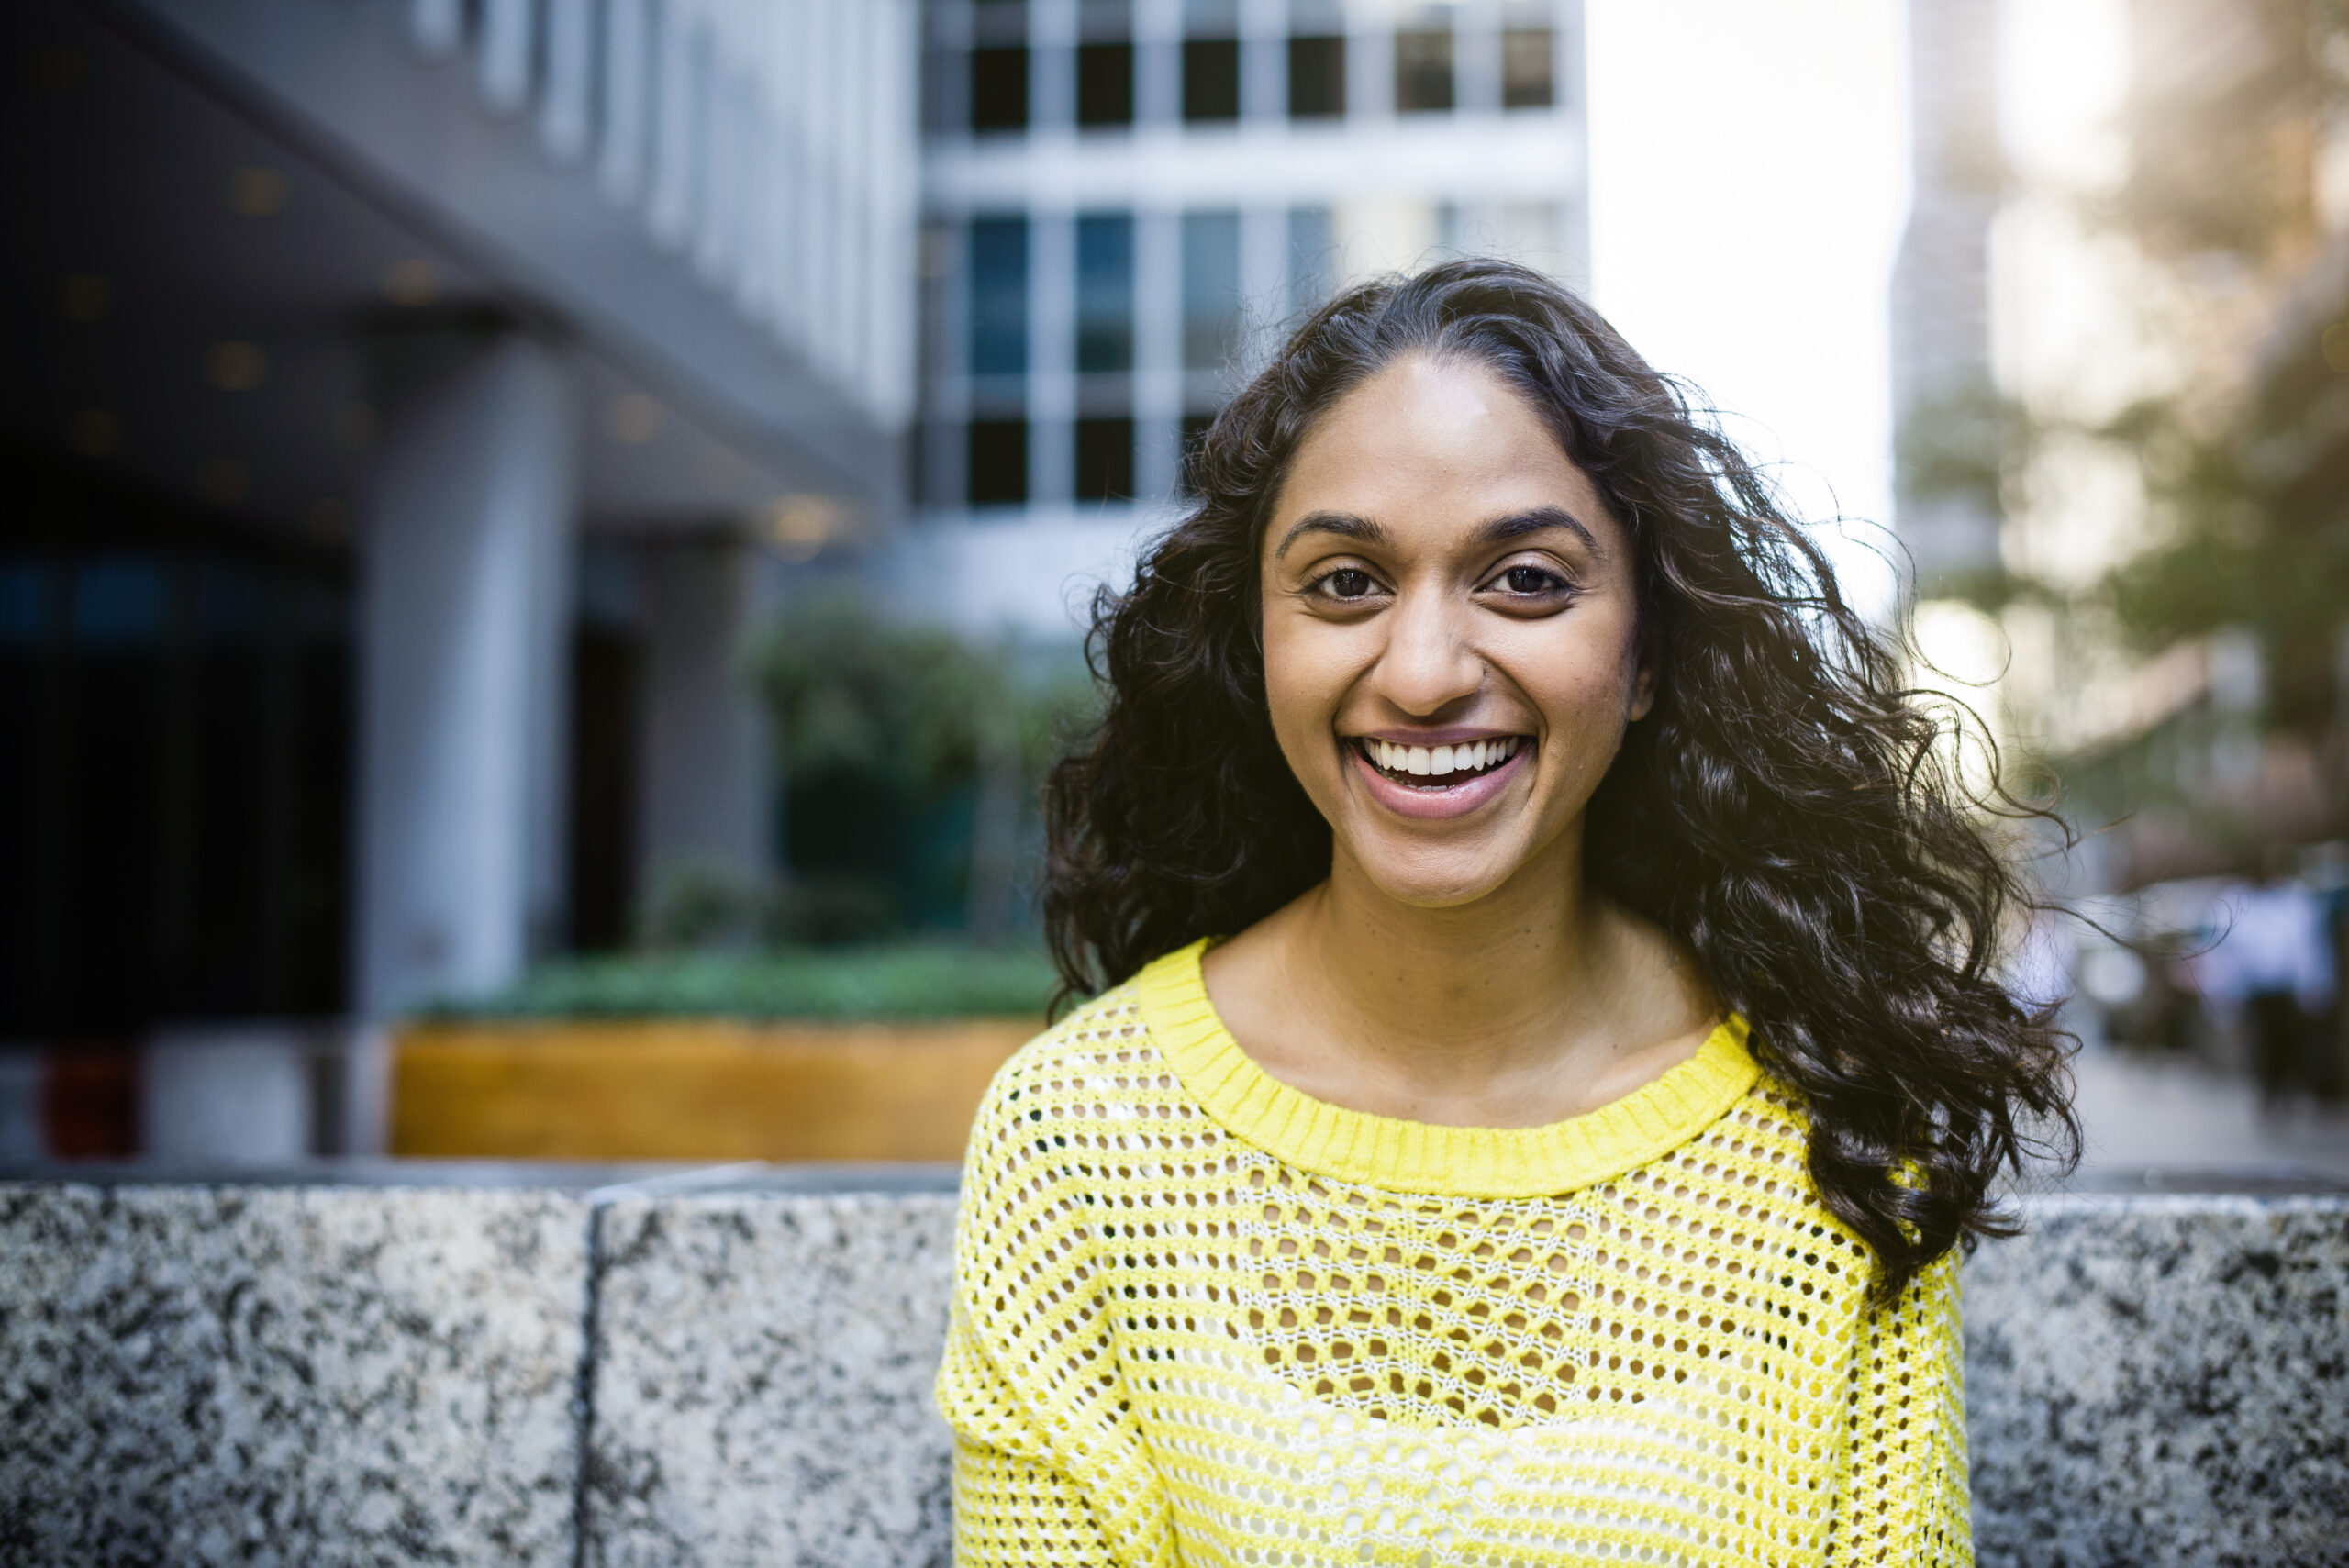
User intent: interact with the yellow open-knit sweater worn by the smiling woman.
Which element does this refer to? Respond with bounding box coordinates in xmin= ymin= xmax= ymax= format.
xmin=937 ymin=943 xmax=1973 ymax=1568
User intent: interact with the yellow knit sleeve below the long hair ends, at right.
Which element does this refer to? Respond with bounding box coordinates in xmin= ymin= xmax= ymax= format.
xmin=1828 ymin=1251 xmax=1973 ymax=1568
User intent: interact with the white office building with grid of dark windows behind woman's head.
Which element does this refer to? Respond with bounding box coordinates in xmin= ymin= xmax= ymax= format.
xmin=881 ymin=0 xmax=1588 ymax=639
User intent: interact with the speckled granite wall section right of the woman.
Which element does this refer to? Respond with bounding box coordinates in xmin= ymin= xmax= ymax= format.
xmin=1964 ymin=1195 xmax=2349 ymax=1568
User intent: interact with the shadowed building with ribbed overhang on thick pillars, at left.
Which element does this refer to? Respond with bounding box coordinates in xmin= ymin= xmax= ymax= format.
xmin=0 ymin=0 xmax=918 ymax=1157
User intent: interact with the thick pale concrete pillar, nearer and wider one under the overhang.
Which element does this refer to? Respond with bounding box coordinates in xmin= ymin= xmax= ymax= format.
xmin=357 ymin=333 xmax=578 ymax=1017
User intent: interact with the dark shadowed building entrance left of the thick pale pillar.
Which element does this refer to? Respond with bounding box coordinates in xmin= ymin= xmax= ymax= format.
xmin=0 ymin=449 xmax=352 ymax=1040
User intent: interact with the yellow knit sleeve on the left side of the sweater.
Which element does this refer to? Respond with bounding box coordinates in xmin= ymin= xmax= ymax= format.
xmin=937 ymin=1059 xmax=1174 ymax=1568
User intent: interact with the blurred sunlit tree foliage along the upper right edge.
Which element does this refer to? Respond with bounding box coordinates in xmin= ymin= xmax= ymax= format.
xmin=2096 ymin=0 xmax=2349 ymax=732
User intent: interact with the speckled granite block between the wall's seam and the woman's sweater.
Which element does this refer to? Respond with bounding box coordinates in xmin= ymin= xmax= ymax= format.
xmin=583 ymin=1173 xmax=953 ymax=1568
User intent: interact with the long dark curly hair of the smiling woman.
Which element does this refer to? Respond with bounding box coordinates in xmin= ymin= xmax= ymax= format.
xmin=1043 ymin=261 xmax=2079 ymax=1300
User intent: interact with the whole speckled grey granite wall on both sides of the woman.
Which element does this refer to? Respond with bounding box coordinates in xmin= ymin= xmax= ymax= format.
xmin=0 ymin=1167 xmax=2349 ymax=1568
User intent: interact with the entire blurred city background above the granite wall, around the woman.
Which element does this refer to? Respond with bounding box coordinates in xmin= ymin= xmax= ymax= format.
xmin=0 ymin=0 xmax=2349 ymax=1173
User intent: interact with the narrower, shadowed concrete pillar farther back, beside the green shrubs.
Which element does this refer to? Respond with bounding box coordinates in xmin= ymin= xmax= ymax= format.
xmin=637 ymin=539 xmax=773 ymax=896
